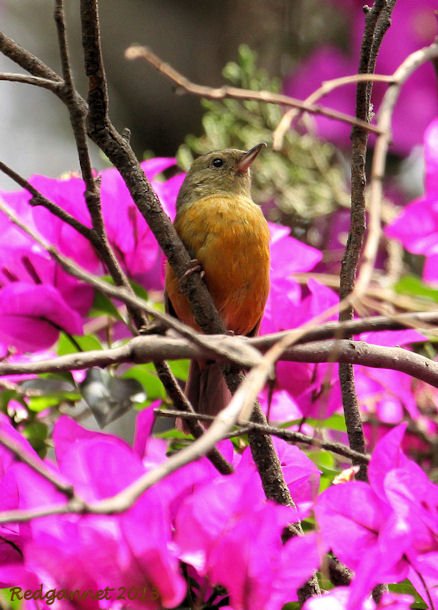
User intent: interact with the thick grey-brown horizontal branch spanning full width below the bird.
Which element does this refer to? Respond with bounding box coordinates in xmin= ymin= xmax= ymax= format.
xmin=0 ymin=331 xmax=438 ymax=384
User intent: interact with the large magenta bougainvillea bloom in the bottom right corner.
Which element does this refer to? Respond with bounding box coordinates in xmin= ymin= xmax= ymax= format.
xmin=315 ymin=424 xmax=438 ymax=610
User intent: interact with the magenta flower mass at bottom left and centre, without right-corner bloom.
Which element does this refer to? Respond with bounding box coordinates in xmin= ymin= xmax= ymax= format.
xmin=0 ymin=409 xmax=326 ymax=610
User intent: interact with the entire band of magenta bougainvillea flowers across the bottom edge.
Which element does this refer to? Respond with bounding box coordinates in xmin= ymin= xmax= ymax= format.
xmin=0 ymin=409 xmax=438 ymax=610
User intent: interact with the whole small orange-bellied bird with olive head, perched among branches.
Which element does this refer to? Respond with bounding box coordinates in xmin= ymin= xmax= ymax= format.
xmin=166 ymin=144 xmax=270 ymax=415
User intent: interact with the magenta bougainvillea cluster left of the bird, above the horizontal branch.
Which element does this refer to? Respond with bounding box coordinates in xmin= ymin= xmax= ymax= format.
xmin=0 ymin=158 xmax=183 ymax=353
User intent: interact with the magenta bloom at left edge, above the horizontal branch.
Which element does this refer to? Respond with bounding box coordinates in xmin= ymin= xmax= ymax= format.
xmin=0 ymin=185 xmax=93 ymax=352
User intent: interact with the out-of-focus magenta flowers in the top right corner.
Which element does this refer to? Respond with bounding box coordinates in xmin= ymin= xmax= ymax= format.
xmin=285 ymin=0 xmax=438 ymax=155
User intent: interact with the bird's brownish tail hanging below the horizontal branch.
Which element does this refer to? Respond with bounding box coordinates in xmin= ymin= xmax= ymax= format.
xmin=186 ymin=360 xmax=231 ymax=416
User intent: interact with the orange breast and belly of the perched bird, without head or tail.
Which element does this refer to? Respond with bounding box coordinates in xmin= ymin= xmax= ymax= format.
xmin=166 ymin=195 xmax=269 ymax=335
